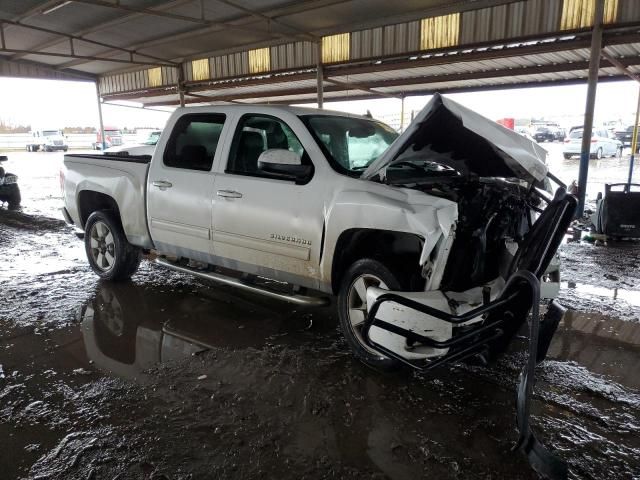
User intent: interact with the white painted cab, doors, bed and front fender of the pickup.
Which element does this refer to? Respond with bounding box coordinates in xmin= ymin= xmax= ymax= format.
xmin=65 ymin=105 xmax=546 ymax=301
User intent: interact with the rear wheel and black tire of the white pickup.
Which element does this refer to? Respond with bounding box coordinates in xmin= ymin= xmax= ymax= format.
xmin=84 ymin=210 xmax=142 ymax=281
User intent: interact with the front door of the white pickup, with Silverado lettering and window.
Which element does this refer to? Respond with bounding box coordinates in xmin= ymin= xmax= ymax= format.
xmin=213 ymin=114 xmax=325 ymax=285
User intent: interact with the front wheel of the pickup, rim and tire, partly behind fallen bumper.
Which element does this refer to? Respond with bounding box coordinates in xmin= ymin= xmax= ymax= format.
xmin=338 ymin=258 xmax=401 ymax=370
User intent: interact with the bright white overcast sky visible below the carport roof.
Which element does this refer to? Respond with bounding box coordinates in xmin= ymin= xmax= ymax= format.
xmin=0 ymin=78 xmax=638 ymax=128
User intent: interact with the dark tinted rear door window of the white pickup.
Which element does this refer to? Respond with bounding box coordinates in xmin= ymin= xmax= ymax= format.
xmin=163 ymin=113 xmax=225 ymax=172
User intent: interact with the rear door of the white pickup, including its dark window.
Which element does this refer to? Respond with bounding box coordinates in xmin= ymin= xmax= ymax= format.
xmin=147 ymin=113 xmax=225 ymax=262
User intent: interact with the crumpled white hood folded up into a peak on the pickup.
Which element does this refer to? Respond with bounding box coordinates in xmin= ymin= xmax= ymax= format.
xmin=361 ymin=93 xmax=547 ymax=182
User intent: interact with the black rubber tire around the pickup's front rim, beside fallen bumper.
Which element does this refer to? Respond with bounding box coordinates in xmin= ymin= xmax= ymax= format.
xmin=338 ymin=258 xmax=402 ymax=370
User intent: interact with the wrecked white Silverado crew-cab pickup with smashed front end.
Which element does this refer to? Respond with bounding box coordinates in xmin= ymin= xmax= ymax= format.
xmin=61 ymin=95 xmax=572 ymax=368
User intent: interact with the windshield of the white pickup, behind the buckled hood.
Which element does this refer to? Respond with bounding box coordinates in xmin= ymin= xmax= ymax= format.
xmin=301 ymin=115 xmax=398 ymax=173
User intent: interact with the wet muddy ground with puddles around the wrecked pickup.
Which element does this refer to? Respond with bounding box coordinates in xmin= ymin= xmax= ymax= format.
xmin=0 ymin=153 xmax=640 ymax=479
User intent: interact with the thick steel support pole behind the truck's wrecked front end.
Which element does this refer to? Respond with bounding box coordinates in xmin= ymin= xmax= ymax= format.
xmin=576 ymin=0 xmax=604 ymax=218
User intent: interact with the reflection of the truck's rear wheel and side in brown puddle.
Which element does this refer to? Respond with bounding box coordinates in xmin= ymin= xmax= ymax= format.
xmin=82 ymin=282 xmax=320 ymax=378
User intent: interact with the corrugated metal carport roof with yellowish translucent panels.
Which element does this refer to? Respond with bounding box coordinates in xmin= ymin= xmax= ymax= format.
xmin=0 ymin=0 xmax=640 ymax=106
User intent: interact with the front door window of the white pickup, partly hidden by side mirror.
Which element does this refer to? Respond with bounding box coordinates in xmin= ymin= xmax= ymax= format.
xmin=226 ymin=115 xmax=311 ymax=177
